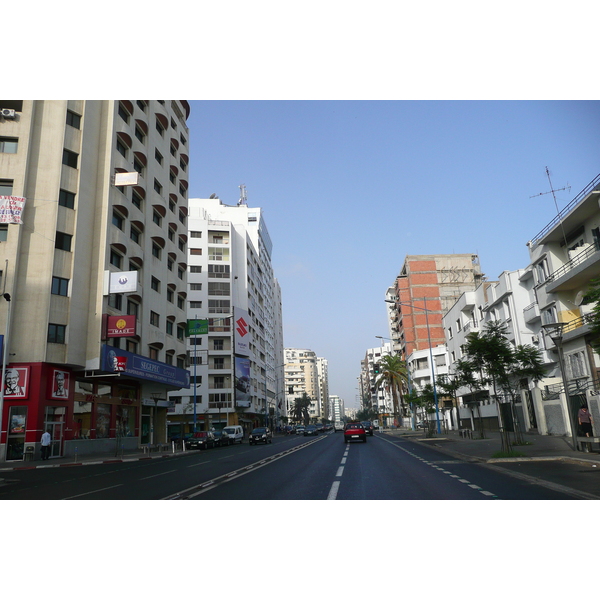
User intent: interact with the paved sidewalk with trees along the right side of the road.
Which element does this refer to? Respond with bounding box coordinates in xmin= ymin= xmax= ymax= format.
xmin=383 ymin=429 xmax=600 ymax=467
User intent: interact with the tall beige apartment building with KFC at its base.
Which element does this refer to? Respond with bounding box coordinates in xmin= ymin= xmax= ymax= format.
xmin=0 ymin=100 xmax=190 ymax=460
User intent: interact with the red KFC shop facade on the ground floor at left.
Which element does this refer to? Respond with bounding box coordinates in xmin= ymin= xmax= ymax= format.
xmin=0 ymin=363 xmax=141 ymax=461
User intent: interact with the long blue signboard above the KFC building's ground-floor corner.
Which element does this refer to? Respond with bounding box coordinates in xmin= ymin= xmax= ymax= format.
xmin=100 ymin=345 xmax=190 ymax=388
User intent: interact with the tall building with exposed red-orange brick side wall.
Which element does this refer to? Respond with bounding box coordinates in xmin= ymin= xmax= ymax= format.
xmin=386 ymin=254 xmax=483 ymax=359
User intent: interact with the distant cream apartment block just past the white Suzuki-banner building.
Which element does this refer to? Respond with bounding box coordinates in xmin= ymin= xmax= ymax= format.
xmin=285 ymin=348 xmax=323 ymax=420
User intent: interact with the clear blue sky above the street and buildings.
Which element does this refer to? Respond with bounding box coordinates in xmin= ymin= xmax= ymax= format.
xmin=188 ymin=101 xmax=600 ymax=406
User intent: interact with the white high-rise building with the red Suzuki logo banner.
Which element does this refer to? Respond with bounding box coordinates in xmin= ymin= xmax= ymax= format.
xmin=169 ymin=198 xmax=285 ymax=435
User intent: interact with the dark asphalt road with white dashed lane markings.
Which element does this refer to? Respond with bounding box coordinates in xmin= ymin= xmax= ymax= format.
xmin=0 ymin=432 xmax=584 ymax=500
